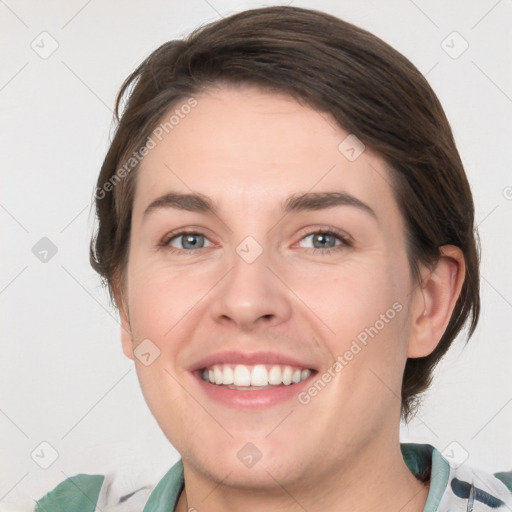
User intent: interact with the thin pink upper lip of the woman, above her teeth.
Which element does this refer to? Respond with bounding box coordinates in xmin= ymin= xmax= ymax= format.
xmin=189 ymin=350 xmax=315 ymax=372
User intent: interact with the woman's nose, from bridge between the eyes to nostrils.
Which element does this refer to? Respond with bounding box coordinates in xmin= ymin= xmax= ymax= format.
xmin=210 ymin=240 xmax=292 ymax=332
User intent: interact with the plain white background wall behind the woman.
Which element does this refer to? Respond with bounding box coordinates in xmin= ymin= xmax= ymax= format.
xmin=0 ymin=0 xmax=512 ymax=502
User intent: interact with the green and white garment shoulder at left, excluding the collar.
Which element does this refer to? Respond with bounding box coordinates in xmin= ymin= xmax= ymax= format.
xmin=34 ymin=473 xmax=154 ymax=512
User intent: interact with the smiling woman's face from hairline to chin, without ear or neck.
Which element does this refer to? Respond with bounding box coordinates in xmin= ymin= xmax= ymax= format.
xmin=122 ymin=87 xmax=420 ymax=487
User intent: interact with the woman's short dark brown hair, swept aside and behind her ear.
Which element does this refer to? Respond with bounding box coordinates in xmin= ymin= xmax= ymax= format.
xmin=90 ymin=6 xmax=480 ymax=421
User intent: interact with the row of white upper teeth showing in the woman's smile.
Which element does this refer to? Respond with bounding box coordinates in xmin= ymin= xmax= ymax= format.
xmin=201 ymin=364 xmax=311 ymax=386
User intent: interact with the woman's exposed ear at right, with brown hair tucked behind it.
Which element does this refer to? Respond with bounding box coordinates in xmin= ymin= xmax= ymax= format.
xmin=407 ymin=245 xmax=466 ymax=358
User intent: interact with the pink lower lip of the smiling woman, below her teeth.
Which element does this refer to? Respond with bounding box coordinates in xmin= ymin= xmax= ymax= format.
xmin=193 ymin=372 xmax=316 ymax=409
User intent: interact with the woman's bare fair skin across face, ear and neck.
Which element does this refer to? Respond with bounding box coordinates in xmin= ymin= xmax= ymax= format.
xmin=118 ymin=86 xmax=464 ymax=512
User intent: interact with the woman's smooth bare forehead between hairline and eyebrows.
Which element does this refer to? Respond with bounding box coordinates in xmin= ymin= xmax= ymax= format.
xmin=130 ymin=86 xmax=400 ymax=228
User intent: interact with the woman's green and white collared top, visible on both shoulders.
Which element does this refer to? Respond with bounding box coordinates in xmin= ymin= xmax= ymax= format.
xmin=35 ymin=443 xmax=512 ymax=512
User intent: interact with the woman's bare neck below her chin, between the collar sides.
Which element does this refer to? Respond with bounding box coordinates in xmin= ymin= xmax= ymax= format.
xmin=175 ymin=439 xmax=429 ymax=512
